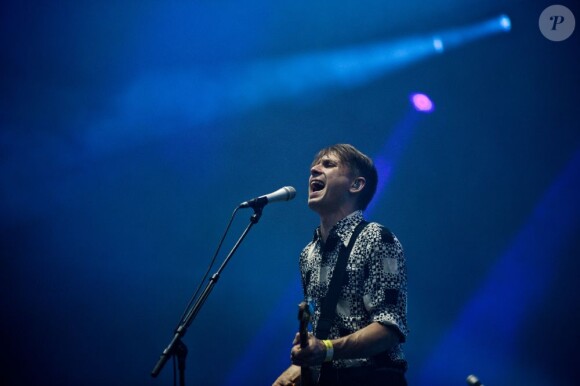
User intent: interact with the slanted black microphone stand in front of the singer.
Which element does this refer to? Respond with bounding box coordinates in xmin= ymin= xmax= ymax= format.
xmin=151 ymin=205 xmax=263 ymax=386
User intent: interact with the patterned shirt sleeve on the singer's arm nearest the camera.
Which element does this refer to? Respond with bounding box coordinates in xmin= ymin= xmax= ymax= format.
xmin=363 ymin=224 xmax=408 ymax=342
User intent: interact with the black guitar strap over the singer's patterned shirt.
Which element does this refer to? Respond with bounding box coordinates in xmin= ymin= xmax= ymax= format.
xmin=314 ymin=220 xmax=368 ymax=339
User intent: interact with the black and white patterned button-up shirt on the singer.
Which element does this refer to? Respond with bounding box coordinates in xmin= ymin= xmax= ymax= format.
xmin=300 ymin=211 xmax=408 ymax=368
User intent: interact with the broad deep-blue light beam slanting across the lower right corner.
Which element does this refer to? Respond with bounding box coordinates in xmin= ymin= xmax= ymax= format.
xmin=409 ymin=151 xmax=580 ymax=385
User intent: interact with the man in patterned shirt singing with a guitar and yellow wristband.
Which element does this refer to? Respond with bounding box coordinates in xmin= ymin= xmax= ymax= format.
xmin=273 ymin=144 xmax=408 ymax=386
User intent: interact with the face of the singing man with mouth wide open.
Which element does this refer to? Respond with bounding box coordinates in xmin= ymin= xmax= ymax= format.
xmin=308 ymin=153 xmax=353 ymax=214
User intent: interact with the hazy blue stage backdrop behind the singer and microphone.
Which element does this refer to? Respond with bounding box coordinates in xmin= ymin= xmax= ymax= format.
xmin=0 ymin=0 xmax=580 ymax=386
